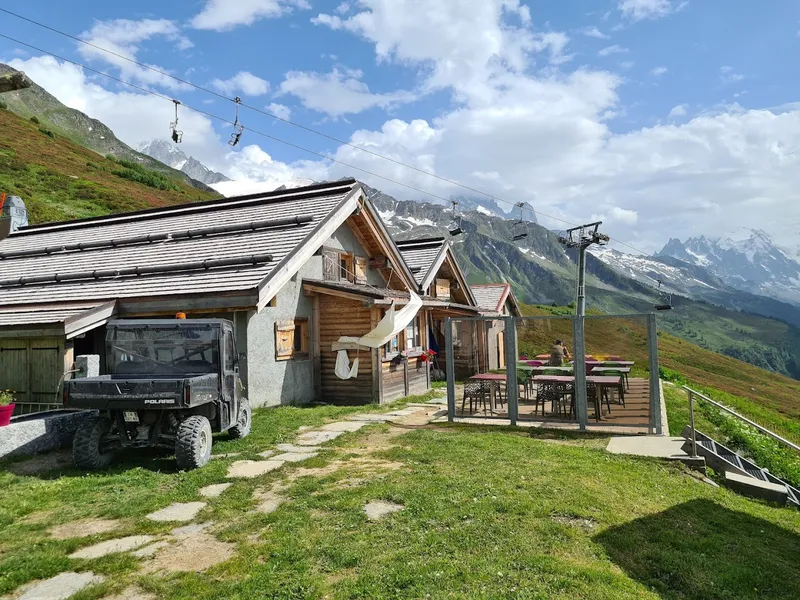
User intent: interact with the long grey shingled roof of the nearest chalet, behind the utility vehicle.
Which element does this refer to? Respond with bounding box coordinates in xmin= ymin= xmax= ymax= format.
xmin=0 ymin=180 xmax=360 ymax=308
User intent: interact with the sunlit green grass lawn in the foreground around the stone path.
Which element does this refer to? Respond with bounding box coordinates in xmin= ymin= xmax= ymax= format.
xmin=0 ymin=394 xmax=800 ymax=600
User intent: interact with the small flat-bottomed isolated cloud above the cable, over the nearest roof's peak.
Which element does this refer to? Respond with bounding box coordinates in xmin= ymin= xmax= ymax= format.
xmin=280 ymin=68 xmax=417 ymax=117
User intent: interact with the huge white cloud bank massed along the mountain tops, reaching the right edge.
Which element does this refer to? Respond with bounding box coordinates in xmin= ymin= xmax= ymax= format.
xmin=7 ymin=0 xmax=800 ymax=251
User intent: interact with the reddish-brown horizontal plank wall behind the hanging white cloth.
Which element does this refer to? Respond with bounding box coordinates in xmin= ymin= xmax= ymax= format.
xmin=319 ymin=294 xmax=378 ymax=404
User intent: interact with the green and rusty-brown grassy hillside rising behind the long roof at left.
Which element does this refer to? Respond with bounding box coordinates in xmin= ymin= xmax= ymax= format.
xmin=0 ymin=105 xmax=219 ymax=223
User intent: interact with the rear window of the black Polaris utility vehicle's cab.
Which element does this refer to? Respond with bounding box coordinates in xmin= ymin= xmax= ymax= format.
xmin=106 ymin=325 xmax=219 ymax=375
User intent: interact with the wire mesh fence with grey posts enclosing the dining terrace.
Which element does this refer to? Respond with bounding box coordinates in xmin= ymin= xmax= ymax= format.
xmin=444 ymin=314 xmax=662 ymax=433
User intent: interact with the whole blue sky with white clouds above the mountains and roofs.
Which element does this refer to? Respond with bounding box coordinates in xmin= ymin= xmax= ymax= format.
xmin=0 ymin=0 xmax=800 ymax=250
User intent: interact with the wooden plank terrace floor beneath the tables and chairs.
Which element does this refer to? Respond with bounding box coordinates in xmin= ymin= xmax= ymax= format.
xmin=456 ymin=377 xmax=650 ymax=433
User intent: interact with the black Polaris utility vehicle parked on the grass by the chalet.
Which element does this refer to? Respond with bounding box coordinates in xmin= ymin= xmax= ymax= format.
xmin=64 ymin=315 xmax=251 ymax=469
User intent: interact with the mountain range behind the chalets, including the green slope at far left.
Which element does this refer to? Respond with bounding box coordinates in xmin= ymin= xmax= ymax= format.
xmin=0 ymin=64 xmax=800 ymax=378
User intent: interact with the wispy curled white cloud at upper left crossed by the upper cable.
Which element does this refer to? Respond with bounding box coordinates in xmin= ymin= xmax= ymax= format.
xmin=78 ymin=19 xmax=192 ymax=89
